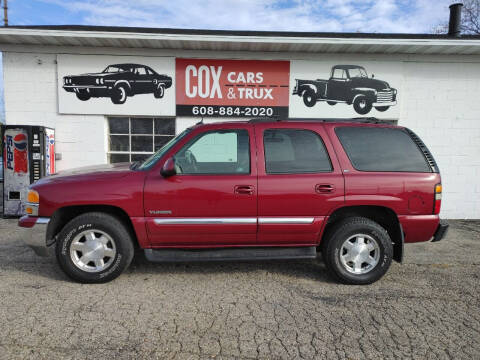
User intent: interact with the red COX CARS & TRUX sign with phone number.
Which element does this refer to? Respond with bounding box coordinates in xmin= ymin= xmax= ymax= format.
xmin=176 ymin=59 xmax=290 ymax=117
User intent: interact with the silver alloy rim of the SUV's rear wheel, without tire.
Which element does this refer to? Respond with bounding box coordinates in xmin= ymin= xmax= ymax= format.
xmin=340 ymin=234 xmax=380 ymax=275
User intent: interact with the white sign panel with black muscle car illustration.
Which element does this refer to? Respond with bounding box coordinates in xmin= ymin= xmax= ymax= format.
xmin=57 ymin=54 xmax=175 ymax=116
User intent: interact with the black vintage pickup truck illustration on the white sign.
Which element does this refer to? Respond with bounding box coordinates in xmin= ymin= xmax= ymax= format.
xmin=293 ymin=65 xmax=397 ymax=115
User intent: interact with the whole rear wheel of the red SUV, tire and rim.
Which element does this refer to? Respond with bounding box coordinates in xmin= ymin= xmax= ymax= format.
xmin=322 ymin=217 xmax=393 ymax=285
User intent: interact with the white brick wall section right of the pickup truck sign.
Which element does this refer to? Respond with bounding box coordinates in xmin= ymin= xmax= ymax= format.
xmin=399 ymin=62 xmax=480 ymax=219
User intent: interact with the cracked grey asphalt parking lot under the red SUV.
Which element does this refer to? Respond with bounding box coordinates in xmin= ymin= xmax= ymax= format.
xmin=0 ymin=220 xmax=480 ymax=359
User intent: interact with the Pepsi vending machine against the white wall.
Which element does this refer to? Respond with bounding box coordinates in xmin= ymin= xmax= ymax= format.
xmin=2 ymin=125 xmax=55 ymax=216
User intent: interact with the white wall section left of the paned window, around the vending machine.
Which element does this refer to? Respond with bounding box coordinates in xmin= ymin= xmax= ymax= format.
xmin=3 ymin=53 xmax=107 ymax=170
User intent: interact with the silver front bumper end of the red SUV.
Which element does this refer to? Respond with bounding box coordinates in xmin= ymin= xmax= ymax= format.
xmin=18 ymin=215 xmax=50 ymax=256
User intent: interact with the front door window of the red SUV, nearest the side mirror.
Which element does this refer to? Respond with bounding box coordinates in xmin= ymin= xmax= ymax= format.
xmin=175 ymin=130 xmax=250 ymax=175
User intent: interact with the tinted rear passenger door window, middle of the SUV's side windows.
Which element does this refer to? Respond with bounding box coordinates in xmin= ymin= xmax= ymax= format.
xmin=263 ymin=129 xmax=332 ymax=174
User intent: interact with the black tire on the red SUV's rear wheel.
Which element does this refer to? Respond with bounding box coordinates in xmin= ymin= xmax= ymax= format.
xmin=322 ymin=217 xmax=393 ymax=285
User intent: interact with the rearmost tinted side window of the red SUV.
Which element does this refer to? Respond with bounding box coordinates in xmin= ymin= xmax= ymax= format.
xmin=335 ymin=127 xmax=431 ymax=172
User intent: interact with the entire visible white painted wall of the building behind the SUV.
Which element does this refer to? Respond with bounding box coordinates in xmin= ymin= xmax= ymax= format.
xmin=3 ymin=47 xmax=480 ymax=218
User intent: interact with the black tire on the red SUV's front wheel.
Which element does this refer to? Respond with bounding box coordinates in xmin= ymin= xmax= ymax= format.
xmin=55 ymin=212 xmax=134 ymax=283
